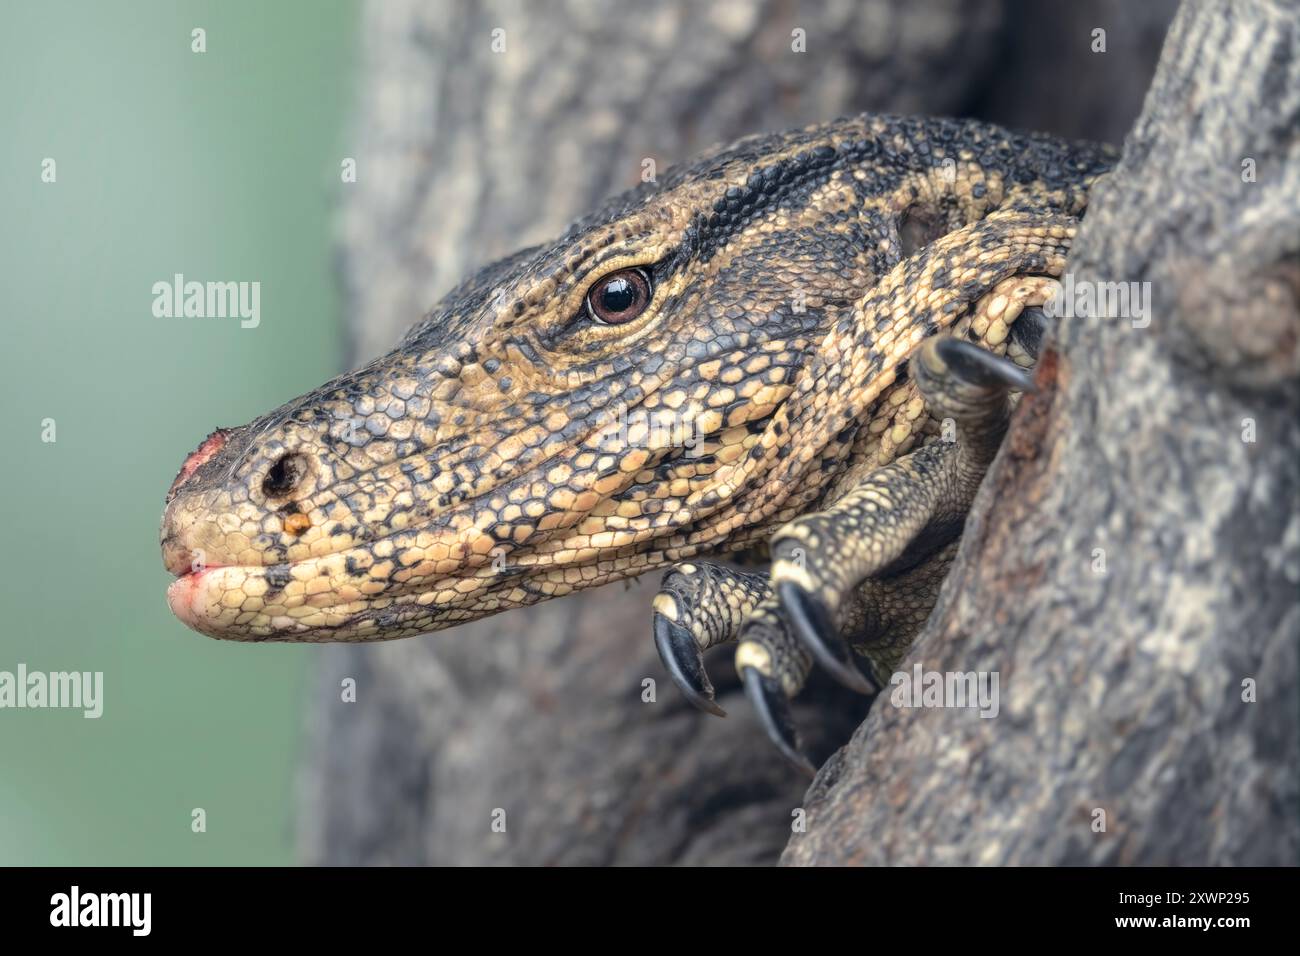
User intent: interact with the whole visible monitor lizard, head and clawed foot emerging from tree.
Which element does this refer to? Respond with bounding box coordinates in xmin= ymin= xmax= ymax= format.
xmin=161 ymin=114 xmax=1115 ymax=770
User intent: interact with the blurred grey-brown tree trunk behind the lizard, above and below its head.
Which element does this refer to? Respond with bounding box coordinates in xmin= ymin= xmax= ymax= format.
xmin=299 ymin=0 xmax=1190 ymax=864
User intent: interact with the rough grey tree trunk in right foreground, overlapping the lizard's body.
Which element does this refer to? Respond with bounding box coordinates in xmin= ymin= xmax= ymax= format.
xmin=783 ymin=0 xmax=1300 ymax=865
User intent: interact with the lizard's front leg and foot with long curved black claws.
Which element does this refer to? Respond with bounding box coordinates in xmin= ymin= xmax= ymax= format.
xmin=654 ymin=276 xmax=1054 ymax=769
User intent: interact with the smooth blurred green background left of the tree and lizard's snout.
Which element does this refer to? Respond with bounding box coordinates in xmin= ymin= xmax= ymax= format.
xmin=0 ymin=0 xmax=358 ymax=865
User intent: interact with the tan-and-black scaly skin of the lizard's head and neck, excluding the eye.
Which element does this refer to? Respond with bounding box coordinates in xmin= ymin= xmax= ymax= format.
xmin=163 ymin=116 xmax=1113 ymax=754
